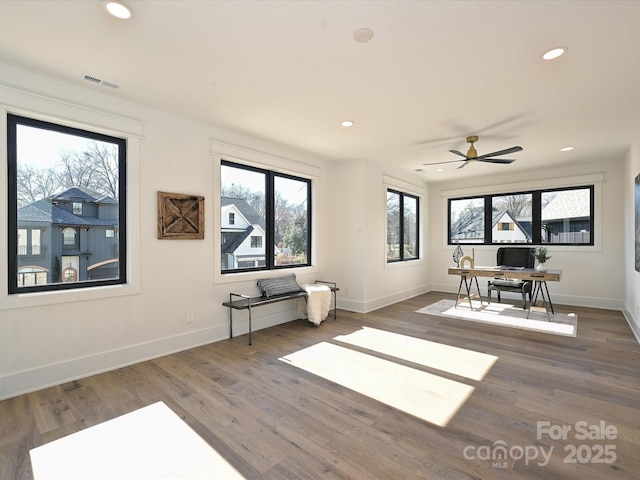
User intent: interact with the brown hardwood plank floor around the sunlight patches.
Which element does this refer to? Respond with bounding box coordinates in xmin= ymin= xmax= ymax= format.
xmin=0 ymin=293 xmax=640 ymax=480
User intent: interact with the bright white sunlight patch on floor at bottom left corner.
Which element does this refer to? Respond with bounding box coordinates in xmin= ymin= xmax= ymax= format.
xmin=29 ymin=402 xmax=244 ymax=480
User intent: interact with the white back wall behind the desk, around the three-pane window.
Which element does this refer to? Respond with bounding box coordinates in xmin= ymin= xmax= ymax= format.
xmin=429 ymin=158 xmax=626 ymax=309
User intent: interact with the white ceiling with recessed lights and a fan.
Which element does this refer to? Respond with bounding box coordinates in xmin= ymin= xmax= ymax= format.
xmin=0 ymin=0 xmax=640 ymax=181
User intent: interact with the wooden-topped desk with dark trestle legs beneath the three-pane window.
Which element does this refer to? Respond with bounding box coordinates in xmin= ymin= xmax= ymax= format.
xmin=449 ymin=267 xmax=562 ymax=321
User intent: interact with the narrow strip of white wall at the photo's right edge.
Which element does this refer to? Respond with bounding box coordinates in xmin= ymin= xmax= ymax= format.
xmin=623 ymin=134 xmax=640 ymax=342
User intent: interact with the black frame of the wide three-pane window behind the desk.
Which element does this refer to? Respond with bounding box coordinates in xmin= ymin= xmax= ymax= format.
xmin=446 ymin=184 xmax=596 ymax=247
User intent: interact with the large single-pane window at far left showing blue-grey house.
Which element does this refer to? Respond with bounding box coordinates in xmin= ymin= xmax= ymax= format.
xmin=7 ymin=115 xmax=127 ymax=294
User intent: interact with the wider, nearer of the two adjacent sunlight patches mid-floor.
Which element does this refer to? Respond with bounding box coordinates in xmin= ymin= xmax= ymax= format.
xmin=280 ymin=342 xmax=474 ymax=427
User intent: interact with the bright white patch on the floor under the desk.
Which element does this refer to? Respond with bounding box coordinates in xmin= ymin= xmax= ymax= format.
xmin=416 ymin=299 xmax=578 ymax=337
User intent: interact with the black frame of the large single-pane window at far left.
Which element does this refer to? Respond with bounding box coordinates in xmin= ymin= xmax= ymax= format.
xmin=6 ymin=111 xmax=129 ymax=295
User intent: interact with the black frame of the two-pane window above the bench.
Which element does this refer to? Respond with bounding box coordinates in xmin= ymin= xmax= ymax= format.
xmin=217 ymin=157 xmax=313 ymax=278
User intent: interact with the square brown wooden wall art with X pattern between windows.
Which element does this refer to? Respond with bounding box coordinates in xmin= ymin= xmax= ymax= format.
xmin=158 ymin=192 xmax=204 ymax=240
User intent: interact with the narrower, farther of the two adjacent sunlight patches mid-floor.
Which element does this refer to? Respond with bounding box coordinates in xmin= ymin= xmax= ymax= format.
xmin=334 ymin=327 xmax=498 ymax=380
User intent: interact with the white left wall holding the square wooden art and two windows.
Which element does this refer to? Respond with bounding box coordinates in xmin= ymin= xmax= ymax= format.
xmin=0 ymin=64 xmax=352 ymax=399
